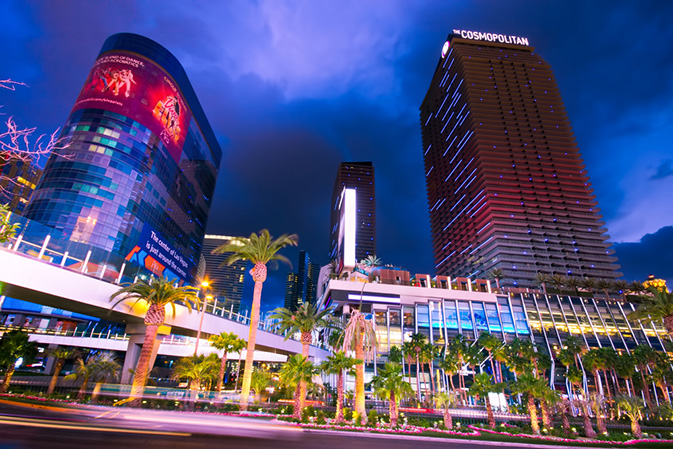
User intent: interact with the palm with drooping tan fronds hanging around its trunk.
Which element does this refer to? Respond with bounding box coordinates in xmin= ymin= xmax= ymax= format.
xmin=343 ymin=310 xmax=376 ymax=423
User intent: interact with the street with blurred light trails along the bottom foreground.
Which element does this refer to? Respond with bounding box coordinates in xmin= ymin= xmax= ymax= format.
xmin=0 ymin=400 xmax=588 ymax=449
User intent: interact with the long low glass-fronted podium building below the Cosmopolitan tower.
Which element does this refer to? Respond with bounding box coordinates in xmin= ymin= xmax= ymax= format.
xmin=323 ymin=269 xmax=671 ymax=400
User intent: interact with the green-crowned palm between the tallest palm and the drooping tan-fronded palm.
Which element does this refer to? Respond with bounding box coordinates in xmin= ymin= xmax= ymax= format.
xmin=269 ymin=302 xmax=334 ymax=408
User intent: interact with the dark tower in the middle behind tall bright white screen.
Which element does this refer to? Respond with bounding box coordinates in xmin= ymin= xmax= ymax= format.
xmin=329 ymin=162 xmax=376 ymax=261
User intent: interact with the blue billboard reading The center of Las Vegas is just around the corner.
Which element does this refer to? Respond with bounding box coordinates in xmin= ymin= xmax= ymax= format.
xmin=126 ymin=223 xmax=194 ymax=281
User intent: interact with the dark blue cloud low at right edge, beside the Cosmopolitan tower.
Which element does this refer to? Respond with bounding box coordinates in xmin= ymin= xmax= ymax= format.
xmin=614 ymin=226 xmax=673 ymax=287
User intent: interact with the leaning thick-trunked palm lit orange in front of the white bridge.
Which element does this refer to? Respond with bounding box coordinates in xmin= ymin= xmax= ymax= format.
xmin=110 ymin=277 xmax=201 ymax=406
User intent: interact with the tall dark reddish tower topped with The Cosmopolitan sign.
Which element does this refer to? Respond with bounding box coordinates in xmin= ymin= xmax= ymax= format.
xmin=420 ymin=30 xmax=620 ymax=287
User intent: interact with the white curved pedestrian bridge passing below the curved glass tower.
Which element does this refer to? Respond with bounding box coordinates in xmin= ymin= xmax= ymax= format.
xmin=0 ymin=234 xmax=329 ymax=359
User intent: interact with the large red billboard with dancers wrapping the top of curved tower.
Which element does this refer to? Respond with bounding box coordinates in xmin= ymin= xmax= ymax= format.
xmin=73 ymin=52 xmax=191 ymax=162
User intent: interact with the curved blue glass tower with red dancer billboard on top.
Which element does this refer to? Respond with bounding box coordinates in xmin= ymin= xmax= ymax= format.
xmin=25 ymin=33 xmax=222 ymax=280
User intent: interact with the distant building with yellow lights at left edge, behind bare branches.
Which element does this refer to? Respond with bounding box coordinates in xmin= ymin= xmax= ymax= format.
xmin=0 ymin=159 xmax=42 ymax=215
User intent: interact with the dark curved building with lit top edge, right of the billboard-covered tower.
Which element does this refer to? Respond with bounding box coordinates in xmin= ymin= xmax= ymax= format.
xmin=201 ymin=234 xmax=247 ymax=313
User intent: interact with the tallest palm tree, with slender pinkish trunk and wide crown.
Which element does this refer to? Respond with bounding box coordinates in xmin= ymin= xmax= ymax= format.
xmin=213 ymin=229 xmax=297 ymax=410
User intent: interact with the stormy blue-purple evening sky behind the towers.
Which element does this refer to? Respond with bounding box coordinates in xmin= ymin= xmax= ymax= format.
xmin=0 ymin=0 xmax=673 ymax=316
